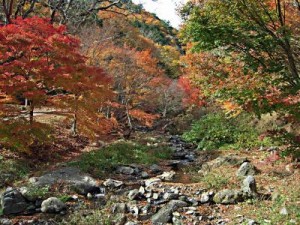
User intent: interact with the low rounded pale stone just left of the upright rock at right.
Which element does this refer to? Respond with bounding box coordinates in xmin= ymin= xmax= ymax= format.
xmin=213 ymin=189 xmax=243 ymax=204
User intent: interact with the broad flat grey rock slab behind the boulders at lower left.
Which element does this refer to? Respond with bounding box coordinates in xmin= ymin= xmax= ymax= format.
xmin=29 ymin=167 xmax=99 ymax=195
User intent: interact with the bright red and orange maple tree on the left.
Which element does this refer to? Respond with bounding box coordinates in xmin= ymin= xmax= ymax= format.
xmin=0 ymin=17 xmax=111 ymax=137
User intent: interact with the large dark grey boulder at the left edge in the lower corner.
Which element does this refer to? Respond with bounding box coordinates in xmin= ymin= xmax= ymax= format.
xmin=0 ymin=189 xmax=30 ymax=215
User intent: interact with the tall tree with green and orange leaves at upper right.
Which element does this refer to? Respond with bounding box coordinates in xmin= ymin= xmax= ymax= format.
xmin=181 ymin=0 xmax=300 ymax=118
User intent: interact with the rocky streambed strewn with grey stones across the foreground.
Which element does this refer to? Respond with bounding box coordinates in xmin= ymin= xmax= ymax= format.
xmin=0 ymin=136 xmax=298 ymax=225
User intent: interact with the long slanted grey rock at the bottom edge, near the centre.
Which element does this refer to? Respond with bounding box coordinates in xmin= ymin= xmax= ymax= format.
xmin=151 ymin=200 xmax=187 ymax=225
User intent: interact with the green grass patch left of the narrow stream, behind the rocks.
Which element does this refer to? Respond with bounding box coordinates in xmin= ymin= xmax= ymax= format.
xmin=70 ymin=141 xmax=172 ymax=176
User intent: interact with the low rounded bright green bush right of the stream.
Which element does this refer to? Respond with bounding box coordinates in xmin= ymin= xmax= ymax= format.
xmin=183 ymin=112 xmax=271 ymax=150
